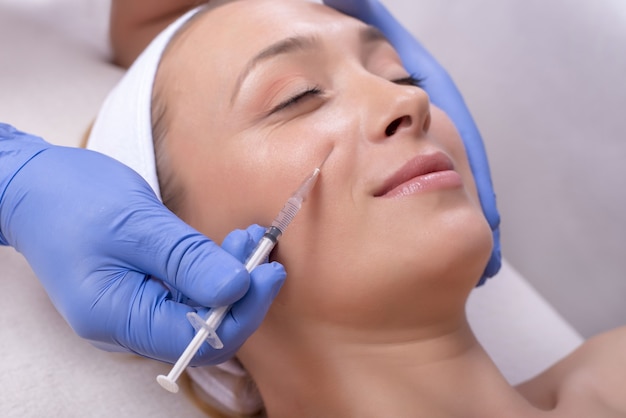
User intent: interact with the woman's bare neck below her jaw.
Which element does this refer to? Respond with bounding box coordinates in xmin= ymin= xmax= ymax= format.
xmin=244 ymin=317 xmax=534 ymax=418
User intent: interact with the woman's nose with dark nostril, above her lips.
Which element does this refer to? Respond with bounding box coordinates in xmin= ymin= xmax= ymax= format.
xmin=364 ymin=79 xmax=431 ymax=142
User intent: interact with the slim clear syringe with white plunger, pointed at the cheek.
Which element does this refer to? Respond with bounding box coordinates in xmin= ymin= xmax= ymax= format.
xmin=157 ymin=150 xmax=332 ymax=393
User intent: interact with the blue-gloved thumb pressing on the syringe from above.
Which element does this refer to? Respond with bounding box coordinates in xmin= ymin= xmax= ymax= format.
xmin=97 ymin=177 xmax=250 ymax=306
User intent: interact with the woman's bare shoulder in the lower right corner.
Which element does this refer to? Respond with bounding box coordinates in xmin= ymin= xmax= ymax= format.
xmin=518 ymin=326 xmax=626 ymax=417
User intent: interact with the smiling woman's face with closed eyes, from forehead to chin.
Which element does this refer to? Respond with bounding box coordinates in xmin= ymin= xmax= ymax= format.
xmin=157 ymin=0 xmax=491 ymax=332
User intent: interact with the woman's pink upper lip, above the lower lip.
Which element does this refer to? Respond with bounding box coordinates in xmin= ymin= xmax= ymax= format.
xmin=374 ymin=152 xmax=454 ymax=197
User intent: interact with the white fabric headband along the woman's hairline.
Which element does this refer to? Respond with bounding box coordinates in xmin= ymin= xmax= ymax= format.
xmin=87 ymin=7 xmax=200 ymax=199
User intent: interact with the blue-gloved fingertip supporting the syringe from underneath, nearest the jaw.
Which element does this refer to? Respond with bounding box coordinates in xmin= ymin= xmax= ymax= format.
xmin=192 ymin=262 xmax=287 ymax=365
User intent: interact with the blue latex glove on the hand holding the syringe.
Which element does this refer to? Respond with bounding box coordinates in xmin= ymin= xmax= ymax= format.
xmin=0 ymin=124 xmax=285 ymax=365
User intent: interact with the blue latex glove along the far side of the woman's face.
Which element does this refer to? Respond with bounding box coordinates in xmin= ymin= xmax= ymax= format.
xmin=324 ymin=0 xmax=502 ymax=285
